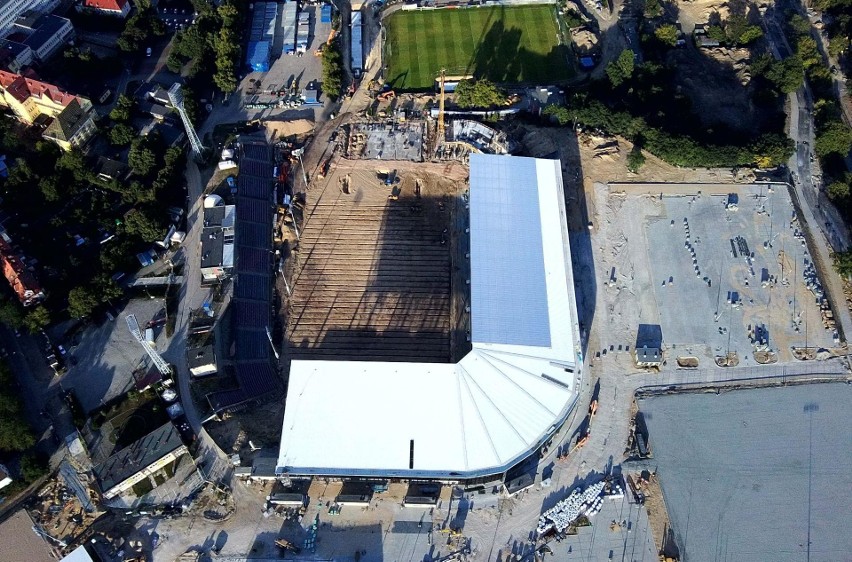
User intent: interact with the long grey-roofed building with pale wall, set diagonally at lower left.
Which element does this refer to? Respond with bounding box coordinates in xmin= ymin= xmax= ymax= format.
xmin=93 ymin=422 xmax=187 ymax=499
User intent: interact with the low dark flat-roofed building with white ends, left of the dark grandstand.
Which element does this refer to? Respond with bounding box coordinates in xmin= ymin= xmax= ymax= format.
xmin=201 ymin=195 xmax=237 ymax=283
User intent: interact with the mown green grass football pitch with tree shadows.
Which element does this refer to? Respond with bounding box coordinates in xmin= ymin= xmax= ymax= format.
xmin=385 ymin=5 xmax=573 ymax=90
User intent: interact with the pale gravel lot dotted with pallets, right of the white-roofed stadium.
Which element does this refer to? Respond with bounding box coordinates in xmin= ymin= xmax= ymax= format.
xmin=590 ymin=183 xmax=842 ymax=368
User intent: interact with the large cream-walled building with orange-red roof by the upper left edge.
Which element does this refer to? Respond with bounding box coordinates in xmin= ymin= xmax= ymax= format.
xmin=0 ymin=70 xmax=92 ymax=125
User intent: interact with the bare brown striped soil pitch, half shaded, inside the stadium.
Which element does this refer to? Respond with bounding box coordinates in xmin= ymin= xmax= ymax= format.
xmin=287 ymin=160 xmax=467 ymax=362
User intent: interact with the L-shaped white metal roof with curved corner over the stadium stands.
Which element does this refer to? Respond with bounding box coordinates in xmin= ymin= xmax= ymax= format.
xmin=278 ymin=154 xmax=582 ymax=479
